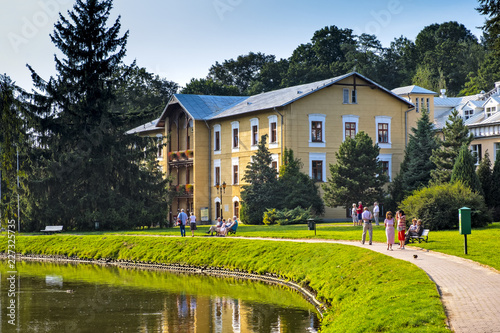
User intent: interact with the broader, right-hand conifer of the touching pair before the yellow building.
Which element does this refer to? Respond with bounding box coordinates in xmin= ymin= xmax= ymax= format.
xmin=276 ymin=148 xmax=325 ymax=215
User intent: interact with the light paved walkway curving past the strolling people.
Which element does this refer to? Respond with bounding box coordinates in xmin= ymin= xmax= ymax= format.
xmin=243 ymin=233 xmax=500 ymax=333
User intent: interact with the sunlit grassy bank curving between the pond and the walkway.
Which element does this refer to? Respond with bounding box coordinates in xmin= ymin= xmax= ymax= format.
xmin=0 ymin=235 xmax=447 ymax=332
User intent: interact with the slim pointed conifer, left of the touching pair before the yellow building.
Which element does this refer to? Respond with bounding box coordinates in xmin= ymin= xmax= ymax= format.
xmin=240 ymin=135 xmax=281 ymax=224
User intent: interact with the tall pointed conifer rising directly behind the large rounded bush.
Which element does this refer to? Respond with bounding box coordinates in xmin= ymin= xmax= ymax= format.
xmin=431 ymin=110 xmax=473 ymax=184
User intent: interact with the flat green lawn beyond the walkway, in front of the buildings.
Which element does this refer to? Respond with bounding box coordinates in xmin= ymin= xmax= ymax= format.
xmin=59 ymin=222 xmax=500 ymax=270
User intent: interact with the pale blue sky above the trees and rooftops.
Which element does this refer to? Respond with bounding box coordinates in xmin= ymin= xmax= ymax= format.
xmin=0 ymin=0 xmax=485 ymax=90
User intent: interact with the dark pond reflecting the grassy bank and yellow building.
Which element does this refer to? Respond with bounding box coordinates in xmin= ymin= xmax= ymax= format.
xmin=0 ymin=262 xmax=319 ymax=333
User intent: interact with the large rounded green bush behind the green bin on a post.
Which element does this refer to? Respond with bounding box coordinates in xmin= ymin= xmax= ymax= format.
xmin=400 ymin=182 xmax=491 ymax=230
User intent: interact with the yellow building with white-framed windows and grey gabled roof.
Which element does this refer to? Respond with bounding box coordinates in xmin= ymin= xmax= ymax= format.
xmin=129 ymin=72 xmax=418 ymax=221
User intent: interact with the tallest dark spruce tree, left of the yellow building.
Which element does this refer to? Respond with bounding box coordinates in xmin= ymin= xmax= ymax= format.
xmin=29 ymin=0 xmax=166 ymax=229
